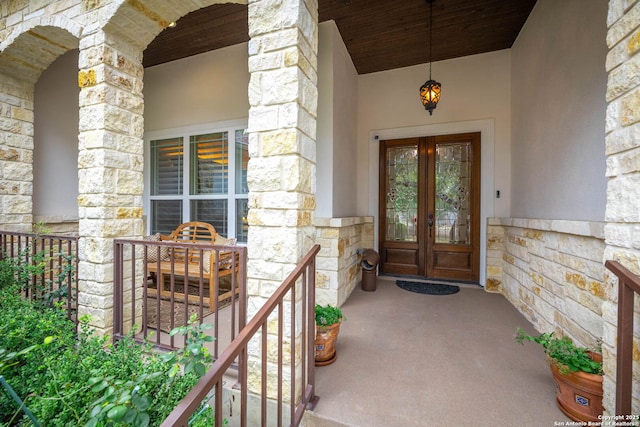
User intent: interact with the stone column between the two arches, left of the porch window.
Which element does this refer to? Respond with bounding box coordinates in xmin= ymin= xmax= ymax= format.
xmin=78 ymin=32 xmax=144 ymax=333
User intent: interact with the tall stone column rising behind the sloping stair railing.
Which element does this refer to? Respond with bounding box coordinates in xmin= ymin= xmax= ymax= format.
xmin=247 ymin=0 xmax=318 ymax=402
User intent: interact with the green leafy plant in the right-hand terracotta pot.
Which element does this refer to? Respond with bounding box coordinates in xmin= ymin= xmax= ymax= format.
xmin=516 ymin=328 xmax=602 ymax=375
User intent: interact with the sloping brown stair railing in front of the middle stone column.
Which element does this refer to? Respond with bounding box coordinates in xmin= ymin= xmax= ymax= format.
xmin=161 ymin=245 xmax=320 ymax=427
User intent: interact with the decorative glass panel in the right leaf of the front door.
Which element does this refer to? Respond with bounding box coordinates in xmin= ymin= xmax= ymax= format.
xmin=435 ymin=142 xmax=472 ymax=245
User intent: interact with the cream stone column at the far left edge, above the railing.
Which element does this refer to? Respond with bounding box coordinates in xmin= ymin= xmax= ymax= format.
xmin=0 ymin=75 xmax=34 ymax=233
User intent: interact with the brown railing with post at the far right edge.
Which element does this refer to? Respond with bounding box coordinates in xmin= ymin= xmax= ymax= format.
xmin=604 ymin=260 xmax=640 ymax=416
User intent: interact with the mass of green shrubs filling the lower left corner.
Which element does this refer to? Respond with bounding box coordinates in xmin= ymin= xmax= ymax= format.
xmin=0 ymin=286 xmax=218 ymax=427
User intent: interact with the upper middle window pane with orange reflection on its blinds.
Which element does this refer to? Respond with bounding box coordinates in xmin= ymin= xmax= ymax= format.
xmin=189 ymin=132 xmax=229 ymax=195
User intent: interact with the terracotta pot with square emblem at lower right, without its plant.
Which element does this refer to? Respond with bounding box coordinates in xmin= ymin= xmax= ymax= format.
xmin=550 ymin=353 xmax=602 ymax=422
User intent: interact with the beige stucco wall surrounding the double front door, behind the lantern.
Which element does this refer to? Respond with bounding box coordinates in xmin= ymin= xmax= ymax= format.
xmin=358 ymin=50 xmax=511 ymax=221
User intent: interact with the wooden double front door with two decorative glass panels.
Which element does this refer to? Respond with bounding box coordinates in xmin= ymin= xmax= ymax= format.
xmin=378 ymin=133 xmax=480 ymax=282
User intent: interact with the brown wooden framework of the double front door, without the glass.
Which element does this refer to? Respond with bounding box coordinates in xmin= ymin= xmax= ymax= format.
xmin=378 ymin=132 xmax=482 ymax=283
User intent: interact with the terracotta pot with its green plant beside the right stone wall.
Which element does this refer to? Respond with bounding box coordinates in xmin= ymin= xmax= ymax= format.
xmin=516 ymin=328 xmax=603 ymax=422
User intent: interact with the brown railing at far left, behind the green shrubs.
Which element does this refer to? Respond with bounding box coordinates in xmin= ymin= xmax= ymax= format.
xmin=0 ymin=231 xmax=78 ymax=326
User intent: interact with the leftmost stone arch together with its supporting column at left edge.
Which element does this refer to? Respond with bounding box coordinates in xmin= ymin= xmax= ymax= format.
xmin=0 ymin=23 xmax=79 ymax=232
